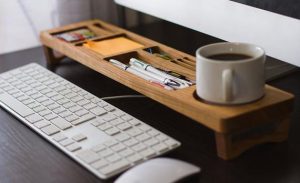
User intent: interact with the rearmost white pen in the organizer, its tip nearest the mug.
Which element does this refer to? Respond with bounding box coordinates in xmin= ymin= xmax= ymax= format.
xmin=129 ymin=58 xmax=192 ymax=88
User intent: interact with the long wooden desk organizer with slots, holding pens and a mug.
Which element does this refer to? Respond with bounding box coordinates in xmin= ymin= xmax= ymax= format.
xmin=40 ymin=20 xmax=294 ymax=160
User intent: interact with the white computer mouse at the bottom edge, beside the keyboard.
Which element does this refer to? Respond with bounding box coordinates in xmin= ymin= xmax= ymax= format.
xmin=115 ymin=158 xmax=200 ymax=183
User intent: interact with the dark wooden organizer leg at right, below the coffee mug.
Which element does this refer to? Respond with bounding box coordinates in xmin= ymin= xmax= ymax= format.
xmin=215 ymin=118 xmax=289 ymax=160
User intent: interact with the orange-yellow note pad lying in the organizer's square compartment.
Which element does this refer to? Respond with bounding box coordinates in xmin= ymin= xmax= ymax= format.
xmin=83 ymin=37 xmax=144 ymax=56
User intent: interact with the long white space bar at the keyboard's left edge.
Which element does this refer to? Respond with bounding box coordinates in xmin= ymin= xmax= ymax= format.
xmin=0 ymin=93 xmax=34 ymax=117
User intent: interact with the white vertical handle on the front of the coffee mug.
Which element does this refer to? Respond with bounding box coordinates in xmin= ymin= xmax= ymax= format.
xmin=222 ymin=69 xmax=233 ymax=102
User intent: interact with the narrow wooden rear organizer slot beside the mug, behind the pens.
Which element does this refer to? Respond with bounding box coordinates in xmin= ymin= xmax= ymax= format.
xmin=144 ymin=46 xmax=196 ymax=71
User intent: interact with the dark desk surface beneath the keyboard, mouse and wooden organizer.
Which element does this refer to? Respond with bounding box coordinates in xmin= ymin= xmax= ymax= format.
xmin=0 ymin=21 xmax=300 ymax=183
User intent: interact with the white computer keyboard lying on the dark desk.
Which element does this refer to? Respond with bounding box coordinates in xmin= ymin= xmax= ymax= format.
xmin=0 ymin=63 xmax=180 ymax=179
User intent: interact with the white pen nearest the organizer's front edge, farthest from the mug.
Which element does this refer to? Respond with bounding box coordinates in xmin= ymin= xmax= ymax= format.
xmin=109 ymin=59 xmax=174 ymax=90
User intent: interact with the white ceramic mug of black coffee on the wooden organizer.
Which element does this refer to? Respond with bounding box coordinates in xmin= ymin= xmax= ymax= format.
xmin=196 ymin=42 xmax=265 ymax=104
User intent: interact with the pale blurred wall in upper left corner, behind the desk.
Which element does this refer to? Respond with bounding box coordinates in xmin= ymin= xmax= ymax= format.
xmin=0 ymin=0 xmax=90 ymax=54
